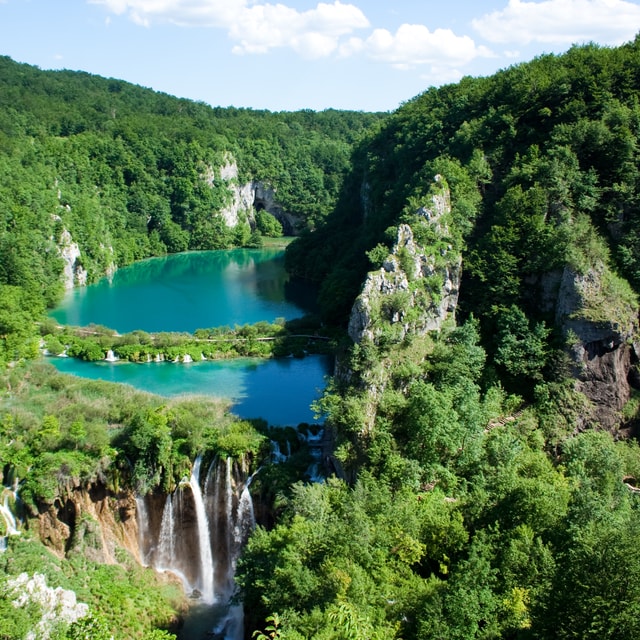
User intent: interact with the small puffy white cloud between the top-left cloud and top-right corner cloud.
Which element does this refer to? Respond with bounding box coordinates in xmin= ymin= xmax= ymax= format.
xmin=362 ymin=24 xmax=493 ymax=70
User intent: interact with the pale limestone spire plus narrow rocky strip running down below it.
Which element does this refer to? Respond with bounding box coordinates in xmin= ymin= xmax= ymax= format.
xmin=336 ymin=176 xmax=462 ymax=431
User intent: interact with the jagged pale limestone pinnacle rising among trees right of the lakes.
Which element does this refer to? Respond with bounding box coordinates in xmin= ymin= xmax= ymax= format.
xmin=348 ymin=176 xmax=462 ymax=343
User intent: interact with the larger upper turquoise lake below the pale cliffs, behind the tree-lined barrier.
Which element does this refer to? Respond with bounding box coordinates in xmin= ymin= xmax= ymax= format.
xmin=51 ymin=249 xmax=311 ymax=333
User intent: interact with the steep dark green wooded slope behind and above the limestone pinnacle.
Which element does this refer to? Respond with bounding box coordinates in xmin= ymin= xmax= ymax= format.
xmin=290 ymin=41 xmax=640 ymax=328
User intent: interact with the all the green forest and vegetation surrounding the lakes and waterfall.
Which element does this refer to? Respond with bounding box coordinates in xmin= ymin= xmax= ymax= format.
xmin=0 ymin=37 xmax=640 ymax=640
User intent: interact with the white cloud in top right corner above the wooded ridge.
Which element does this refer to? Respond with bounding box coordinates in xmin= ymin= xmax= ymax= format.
xmin=472 ymin=0 xmax=640 ymax=45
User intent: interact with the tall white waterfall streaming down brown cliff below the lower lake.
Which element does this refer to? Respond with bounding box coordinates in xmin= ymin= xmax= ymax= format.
xmin=137 ymin=457 xmax=255 ymax=640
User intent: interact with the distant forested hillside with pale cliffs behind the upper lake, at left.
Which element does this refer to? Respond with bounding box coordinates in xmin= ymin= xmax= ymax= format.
xmin=0 ymin=57 xmax=383 ymax=360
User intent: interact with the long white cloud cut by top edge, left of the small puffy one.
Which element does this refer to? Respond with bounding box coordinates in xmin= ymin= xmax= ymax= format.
xmin=89 ymin=0 xmax=369 ymax=58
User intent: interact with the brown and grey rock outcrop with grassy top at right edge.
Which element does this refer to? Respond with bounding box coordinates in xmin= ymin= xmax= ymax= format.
xmin=556 ymin=264 xmax=640 ymax=431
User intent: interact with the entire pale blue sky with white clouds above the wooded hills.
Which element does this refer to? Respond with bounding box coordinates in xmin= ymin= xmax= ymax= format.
xmin=0 ymin=0 xmax=640 ymax=111
